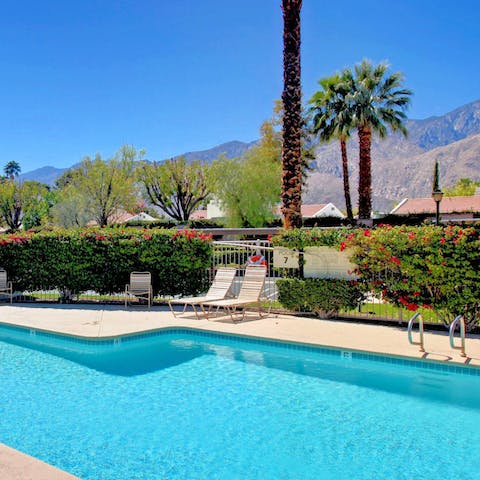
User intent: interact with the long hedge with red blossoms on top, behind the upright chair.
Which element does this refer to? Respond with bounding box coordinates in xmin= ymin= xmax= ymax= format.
xmin=0 ymin=228 xmax=212 ymax=295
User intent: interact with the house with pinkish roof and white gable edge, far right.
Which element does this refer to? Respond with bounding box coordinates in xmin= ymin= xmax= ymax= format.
xmin=390 ymin=193 xmax=480 ymax=220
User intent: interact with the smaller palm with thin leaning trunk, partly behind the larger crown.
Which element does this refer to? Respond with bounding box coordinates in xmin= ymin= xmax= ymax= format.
xmin=309 ymin=70 xmax=353 ymax=222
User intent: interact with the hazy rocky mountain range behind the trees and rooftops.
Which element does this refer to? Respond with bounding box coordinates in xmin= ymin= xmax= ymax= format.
xmin=21 ymin=100 xmax=480 ymax=211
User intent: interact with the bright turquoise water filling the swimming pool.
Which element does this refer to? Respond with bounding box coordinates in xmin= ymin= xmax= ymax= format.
xmin=0 ymin=328 xmax=480 ymax=480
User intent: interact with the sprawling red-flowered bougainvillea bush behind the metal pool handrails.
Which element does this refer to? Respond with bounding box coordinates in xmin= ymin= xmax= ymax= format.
xmin=340 ymin=225 xmax=480 ymax=327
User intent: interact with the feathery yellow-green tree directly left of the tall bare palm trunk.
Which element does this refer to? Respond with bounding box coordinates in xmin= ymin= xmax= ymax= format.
xmin=209 ymin=119 xmax=282 ymax=227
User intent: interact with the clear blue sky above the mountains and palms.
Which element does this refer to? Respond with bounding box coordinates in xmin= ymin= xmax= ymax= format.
xmin=0 ymin=0 xmax=480 ymax=172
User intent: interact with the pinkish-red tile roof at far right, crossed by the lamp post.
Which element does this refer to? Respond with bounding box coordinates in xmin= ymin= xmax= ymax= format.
xmin=392 ymin=195 xmax=480 ymax=215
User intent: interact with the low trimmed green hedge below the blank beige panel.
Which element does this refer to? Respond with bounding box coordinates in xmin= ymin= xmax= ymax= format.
xmin=277 ymin=278 xmax=363 ymax=318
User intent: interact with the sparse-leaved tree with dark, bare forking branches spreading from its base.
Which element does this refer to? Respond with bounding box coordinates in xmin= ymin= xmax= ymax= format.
xmin=138 ymin=157 xmax=210 ymax=222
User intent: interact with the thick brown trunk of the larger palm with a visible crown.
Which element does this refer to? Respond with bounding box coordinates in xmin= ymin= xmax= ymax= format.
xmin=358 ymin=125 xmax=372 ymax=219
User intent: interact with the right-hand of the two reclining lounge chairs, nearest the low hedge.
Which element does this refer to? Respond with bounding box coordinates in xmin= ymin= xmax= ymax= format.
xmin=200 ymin=265 xmax=270 ymax=322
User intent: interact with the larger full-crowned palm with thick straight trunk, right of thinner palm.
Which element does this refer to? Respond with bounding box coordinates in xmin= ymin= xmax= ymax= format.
xmin=348 ymin=60 xmax=412 ymax=219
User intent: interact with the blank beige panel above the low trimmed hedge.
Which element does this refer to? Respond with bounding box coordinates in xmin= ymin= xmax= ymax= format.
xmin=304 ymin=247 xmax=356 ymax=280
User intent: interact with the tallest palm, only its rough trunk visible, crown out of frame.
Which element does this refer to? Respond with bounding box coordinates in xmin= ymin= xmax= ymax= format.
xmin=282 ymin=0 xmax=304 ymax=229
